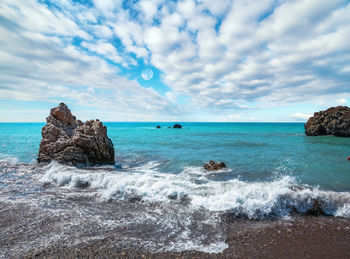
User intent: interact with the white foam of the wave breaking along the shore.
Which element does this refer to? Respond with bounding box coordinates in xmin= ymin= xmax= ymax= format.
xmin=41 ymin=161 xmax=350 ymax=218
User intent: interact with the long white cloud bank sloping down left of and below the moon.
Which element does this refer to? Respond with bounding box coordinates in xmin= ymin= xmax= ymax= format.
xmin=0 ymin=1 xmax=176 ymax=120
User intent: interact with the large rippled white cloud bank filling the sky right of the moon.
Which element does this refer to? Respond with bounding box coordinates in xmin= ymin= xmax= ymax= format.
xmin=139 ymin=0 xmax=350 ymax=108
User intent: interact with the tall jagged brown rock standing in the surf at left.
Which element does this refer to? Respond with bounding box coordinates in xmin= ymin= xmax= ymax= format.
xmin=38 ymin=103 xmax=115 ymax=165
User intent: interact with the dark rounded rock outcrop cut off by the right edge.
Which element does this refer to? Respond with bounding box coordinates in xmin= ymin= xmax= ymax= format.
xmin=305 ymin=106 xmax=350 ymax=137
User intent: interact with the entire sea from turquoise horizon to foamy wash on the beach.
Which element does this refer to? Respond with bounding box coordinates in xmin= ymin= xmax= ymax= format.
xmin=0 ymin=122 xmax=350 ymax=258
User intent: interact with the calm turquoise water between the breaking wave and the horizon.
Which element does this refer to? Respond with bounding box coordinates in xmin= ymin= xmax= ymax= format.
xmin=0 ymin=122 xmax=350 ymax=191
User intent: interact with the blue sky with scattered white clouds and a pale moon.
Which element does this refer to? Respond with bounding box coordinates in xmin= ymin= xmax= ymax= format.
xmin=0 ymin=0 xmax=350 ymax=122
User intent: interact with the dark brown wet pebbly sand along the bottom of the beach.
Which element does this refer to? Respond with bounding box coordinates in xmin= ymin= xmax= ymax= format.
xmin=24 ymin=216 xmax=350 ymax=258
